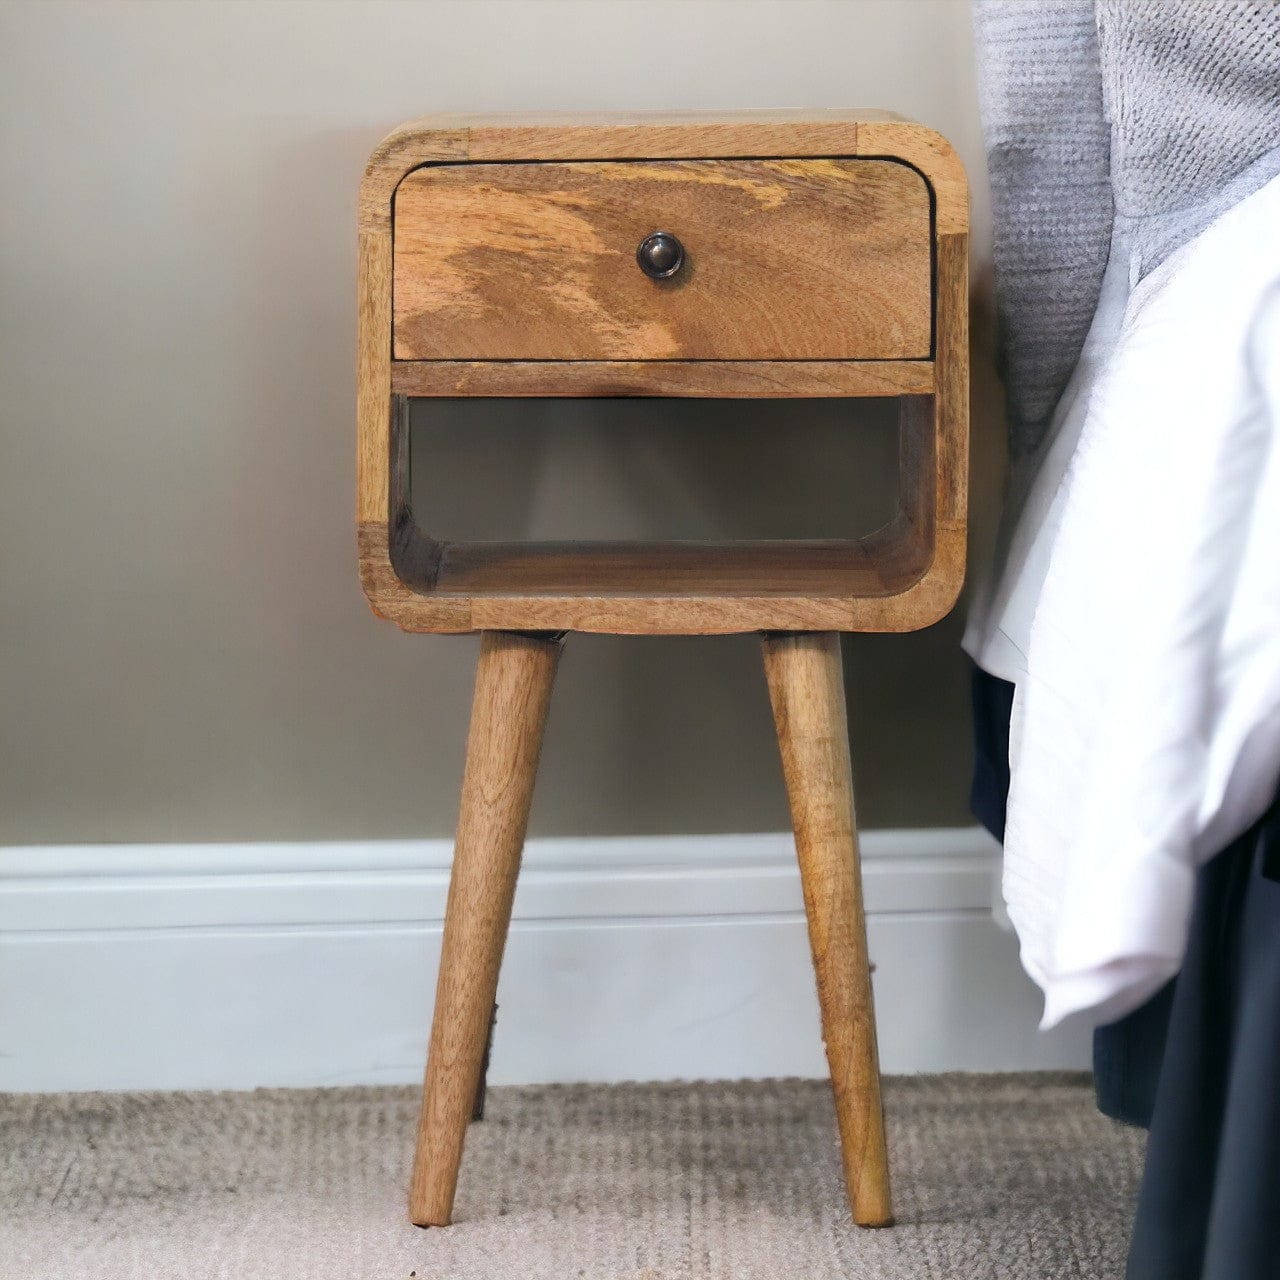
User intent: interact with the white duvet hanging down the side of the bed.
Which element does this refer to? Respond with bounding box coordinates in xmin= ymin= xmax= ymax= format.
xmin=966 ymin=172 xmax=1280 ymax=1025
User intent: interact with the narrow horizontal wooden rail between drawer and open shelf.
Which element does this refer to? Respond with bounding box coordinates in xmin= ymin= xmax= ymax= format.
xmin=392 ymin=360 xmax=933 ymax=399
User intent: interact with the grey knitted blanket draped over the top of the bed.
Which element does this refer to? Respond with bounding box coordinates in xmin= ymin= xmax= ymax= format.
xmin=974 ymin=0 xmax=1280 ymax=466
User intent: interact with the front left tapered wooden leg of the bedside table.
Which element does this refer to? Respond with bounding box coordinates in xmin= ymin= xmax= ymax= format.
xmin=410 ymin=631 xmax=561 ymax=1226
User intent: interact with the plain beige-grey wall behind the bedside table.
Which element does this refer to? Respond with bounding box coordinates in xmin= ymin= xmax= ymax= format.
xmin=0 ymin=0 xmax=998 ymax=844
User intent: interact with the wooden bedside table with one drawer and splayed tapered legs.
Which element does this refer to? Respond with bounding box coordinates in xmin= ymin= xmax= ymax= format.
xmin=357 ymin=111 xmax=969 ymax=1226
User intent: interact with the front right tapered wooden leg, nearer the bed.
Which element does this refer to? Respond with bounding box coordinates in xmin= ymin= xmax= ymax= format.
xmin=764 ymin=632 xmax=893 ymax=1226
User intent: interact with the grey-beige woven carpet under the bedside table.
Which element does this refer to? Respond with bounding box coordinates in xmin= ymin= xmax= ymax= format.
xmin=0 ymin=1075 xmax=1144 ymax=1280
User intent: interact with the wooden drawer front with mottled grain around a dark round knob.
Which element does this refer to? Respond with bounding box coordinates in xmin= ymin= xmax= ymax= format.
xmin=393 ymin=160 xmax=932 ymax=360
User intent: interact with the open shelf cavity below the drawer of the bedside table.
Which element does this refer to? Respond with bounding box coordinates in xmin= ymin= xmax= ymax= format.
xmin=392 ymin=398 xmax=922 ymax=596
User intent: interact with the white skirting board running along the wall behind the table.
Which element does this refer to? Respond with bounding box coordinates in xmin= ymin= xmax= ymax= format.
xmin=0 ymin=828 xmax=1088 ymax=1092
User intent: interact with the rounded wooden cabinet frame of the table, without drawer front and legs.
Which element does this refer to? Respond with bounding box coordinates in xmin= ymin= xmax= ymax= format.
xmin=357 ymin=113 xmax=968 ymax=634
